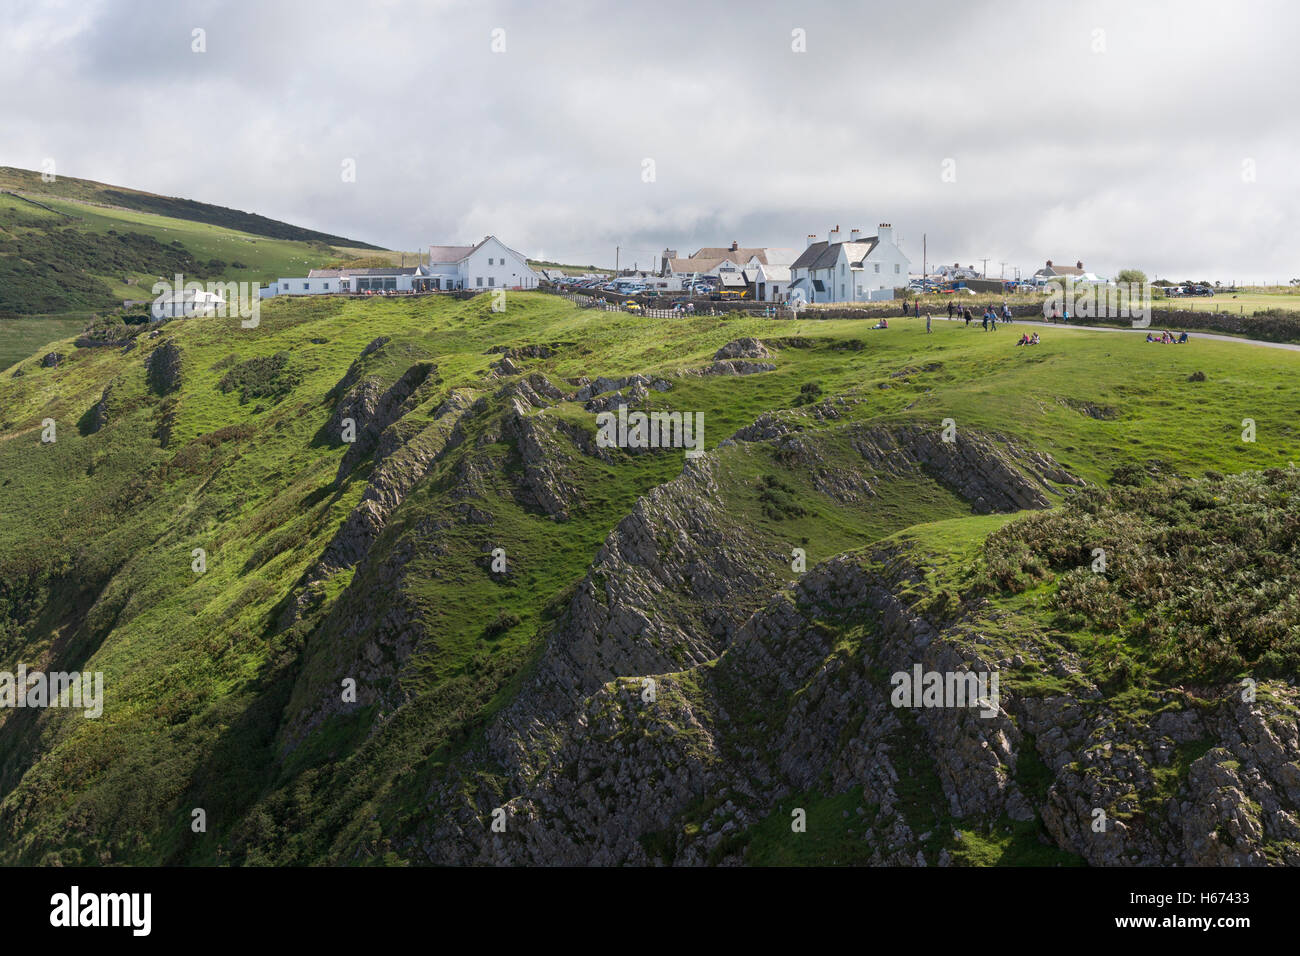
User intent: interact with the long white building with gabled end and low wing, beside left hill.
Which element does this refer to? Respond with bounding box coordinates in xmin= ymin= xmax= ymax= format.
xmin=261 ymin=235 xmax=541 ymax=298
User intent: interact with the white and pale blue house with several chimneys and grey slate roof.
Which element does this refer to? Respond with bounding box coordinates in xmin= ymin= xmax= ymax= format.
xmin=789 ymin=222 xmax=911 ymax=303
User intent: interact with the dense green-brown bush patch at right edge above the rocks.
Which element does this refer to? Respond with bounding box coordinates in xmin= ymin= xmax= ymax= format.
xmin=984 ymin=470 xmax=1300 ymax=680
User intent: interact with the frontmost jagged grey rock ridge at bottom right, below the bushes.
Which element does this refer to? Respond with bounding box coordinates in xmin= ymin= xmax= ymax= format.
xmin=421 ymin=538 xmax=1300 ymax=866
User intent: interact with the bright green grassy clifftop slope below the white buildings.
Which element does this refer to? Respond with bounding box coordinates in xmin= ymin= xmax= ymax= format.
xmin=0 ymin=293 xmax=1300 ymax=864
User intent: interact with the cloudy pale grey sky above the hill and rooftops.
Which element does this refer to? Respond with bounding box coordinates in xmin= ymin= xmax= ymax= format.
xmin=0 ymin=0 xmax=1300 ymax=284
